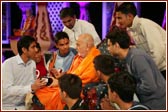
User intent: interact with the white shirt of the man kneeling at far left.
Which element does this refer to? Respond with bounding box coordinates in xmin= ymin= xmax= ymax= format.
xmin=2 ymin=55 xmax=36 ymax=110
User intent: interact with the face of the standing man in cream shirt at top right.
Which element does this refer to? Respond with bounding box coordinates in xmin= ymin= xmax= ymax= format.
xmin=115 ymin=12 xmax=132 ymax=28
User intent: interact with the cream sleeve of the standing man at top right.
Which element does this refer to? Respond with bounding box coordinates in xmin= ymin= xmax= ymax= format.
xmin=141 ymin=24 xmax=166 ymax=67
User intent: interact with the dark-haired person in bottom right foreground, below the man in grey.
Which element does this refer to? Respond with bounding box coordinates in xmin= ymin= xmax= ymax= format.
xmin=108 ymin=72 xmax=149 ymax=110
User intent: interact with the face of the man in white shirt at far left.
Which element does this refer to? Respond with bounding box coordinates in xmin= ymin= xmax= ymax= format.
xmin=24 ymin=42 xmax=38 ymax=60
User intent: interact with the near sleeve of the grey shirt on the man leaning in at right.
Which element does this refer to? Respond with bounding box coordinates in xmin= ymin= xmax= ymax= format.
xmin=131 ymin=55 xmax=157 ymax=95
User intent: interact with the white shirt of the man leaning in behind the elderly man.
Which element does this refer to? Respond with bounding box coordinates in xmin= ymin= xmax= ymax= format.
xmin=63 ymin=19 xmax=101 ymax=48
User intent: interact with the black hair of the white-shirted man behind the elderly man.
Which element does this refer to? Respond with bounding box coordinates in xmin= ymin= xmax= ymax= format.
xmin=59 ymin=7 xmax=75 ymax=19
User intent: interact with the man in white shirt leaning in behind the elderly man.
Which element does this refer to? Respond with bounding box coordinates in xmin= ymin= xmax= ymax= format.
xmin=60 ymin=7 xmax=101 ymax=48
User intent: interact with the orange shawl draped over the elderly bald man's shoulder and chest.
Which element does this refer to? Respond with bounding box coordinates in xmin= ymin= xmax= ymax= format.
xmin=68 ymin=47 xmax=100 ymax=86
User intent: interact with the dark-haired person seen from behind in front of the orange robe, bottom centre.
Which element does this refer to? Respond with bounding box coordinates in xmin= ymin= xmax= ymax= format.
xmin=58 ymin=74 xmax=89 ymax=110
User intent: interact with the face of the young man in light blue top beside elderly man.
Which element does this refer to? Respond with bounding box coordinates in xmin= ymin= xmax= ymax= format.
xmin=56 ymin=38 xmax=69 ymax=55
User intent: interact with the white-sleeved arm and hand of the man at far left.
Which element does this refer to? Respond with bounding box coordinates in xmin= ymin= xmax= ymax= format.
xmin=2 ymin=62 xmax=46 ymax=96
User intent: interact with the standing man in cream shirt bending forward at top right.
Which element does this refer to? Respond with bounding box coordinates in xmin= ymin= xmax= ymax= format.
xmin=116 ymin=2 xmax=166 ymax=77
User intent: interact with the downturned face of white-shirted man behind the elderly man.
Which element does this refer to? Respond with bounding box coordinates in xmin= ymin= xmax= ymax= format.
xmin=61 ymin=16 xmax=76 ymax=29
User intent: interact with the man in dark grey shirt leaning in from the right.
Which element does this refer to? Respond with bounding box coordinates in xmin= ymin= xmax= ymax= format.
xmin=107 ymin=27 xmax=166 ymax=110
